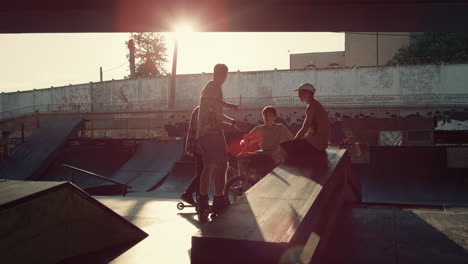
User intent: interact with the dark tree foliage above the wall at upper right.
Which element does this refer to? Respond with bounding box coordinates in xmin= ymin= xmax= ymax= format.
xmin=387 ymin=32 xmax=468 ymax=65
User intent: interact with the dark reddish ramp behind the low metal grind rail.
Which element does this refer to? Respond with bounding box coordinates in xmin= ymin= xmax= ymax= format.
xmin=40 ymin=140 xmax=136 ymax=194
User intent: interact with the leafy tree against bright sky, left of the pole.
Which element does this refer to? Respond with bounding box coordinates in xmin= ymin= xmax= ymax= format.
xmin=125 ymin=32 xmax=167 ymax=78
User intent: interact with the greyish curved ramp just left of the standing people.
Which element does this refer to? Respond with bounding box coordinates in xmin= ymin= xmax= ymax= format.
xmin=87 ymin=140 xmax=184 ymax=193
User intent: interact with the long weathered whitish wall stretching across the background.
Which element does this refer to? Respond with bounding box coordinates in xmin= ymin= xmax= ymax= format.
xmin=0 ymin=64 xmax=468 ymax=112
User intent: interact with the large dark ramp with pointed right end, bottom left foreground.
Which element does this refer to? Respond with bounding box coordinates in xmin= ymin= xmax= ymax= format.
xmin=0 ymin=180 xmax=147 ymax=263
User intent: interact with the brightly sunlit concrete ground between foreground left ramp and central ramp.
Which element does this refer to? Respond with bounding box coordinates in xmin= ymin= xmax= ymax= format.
xmin=95 ymin=192 xmax=199 ymax=264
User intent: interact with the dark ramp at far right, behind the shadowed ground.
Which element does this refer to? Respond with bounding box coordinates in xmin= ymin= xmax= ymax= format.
xmin=361 ymin=146 xmax=468 ymax=205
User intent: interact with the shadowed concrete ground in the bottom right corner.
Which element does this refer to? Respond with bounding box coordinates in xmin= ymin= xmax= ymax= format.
xmin=323 ymin=204 xmax=468 ymax=264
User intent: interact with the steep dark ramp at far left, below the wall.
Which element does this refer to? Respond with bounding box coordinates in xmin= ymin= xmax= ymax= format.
xmin=0 ymin=119 xmax=82 ymax=180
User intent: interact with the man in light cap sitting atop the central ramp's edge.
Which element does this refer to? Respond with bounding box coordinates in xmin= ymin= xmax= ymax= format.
xmin=281 ymin=83 xmax=330 ymax=159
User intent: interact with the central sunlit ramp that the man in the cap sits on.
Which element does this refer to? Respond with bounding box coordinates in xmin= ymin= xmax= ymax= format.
xmin=191 ymin=149 xmax=350 ymax=263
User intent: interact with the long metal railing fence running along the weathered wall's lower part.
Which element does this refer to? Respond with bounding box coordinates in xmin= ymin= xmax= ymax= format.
xmin=0 ymin=94 xmax=468 ymax=120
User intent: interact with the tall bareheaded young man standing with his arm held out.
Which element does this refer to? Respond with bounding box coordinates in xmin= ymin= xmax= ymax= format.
xmin=197 ymin=64 xmax=238 ymax=221
